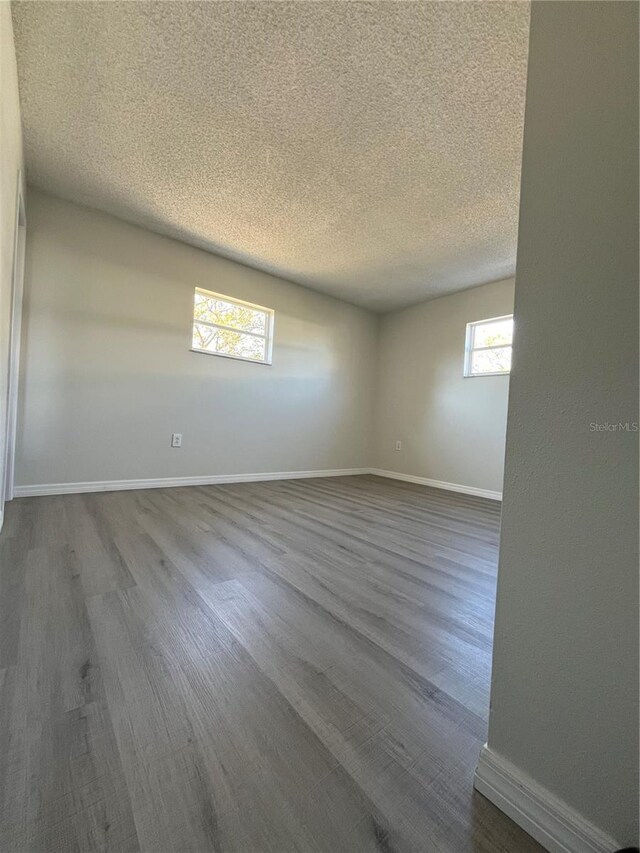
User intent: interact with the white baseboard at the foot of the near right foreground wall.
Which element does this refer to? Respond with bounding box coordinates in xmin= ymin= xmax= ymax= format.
xmin=474 ymin=744 xmax=622 ymax=853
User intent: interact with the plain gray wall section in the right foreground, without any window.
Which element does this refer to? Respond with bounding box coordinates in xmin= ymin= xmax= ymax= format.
xmin=488 ymin=2 xmax=638 ymax=850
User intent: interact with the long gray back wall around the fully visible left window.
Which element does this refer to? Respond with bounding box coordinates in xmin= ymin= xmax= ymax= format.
xmin=16 ymin=192 xmax=377 ymax=486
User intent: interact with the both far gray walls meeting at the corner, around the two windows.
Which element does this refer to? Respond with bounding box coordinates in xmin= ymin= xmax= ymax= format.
xmin=16 ymin=191 xmax=513 ymax=491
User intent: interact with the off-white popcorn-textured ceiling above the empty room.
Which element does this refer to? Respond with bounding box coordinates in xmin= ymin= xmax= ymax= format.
xmin=13 ymin=0 xmax=529 ymax=310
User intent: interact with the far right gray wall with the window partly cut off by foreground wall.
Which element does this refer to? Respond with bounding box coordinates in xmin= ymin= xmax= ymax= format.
xmin=374 ymin=279 xmax=514 ymax=492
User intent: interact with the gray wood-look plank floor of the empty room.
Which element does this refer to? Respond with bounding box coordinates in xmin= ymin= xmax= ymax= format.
xmin=0 ymin=476 xmax=541 ymax=853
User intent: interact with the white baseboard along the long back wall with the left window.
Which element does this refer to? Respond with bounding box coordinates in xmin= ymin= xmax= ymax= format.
xmin=14 ymin=468 xmax=369 ymax=498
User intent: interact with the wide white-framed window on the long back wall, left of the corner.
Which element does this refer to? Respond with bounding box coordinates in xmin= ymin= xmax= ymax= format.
xmin=191 ymin=287 xmax=273 ymax=364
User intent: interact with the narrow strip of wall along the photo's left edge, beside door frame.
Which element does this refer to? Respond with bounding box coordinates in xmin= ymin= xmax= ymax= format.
xmin=0 ymin=3 xmax=22 ymax=526
